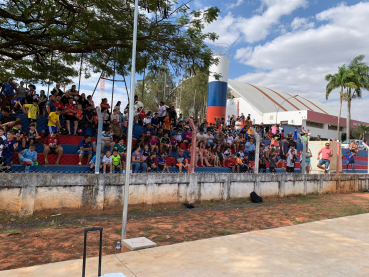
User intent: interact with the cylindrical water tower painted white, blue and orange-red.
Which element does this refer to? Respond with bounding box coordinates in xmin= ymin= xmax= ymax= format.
xmin=206 ymin=43 xmax=229 ymax=123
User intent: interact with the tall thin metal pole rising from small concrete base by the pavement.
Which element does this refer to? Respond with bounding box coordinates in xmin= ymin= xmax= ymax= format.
xmin=122 ymin=0 xmax=138 ymax=241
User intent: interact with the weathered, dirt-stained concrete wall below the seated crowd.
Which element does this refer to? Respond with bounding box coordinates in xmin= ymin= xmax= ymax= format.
xmin=0 ymin=173 xmax=369 ymax=217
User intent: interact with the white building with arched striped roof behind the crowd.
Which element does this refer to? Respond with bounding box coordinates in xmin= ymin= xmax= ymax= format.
xmin=227 ymin=80 xmax=369 ymax=138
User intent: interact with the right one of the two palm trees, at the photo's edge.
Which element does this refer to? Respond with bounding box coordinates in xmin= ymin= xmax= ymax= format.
xmin=345 ymin=55 xmax=369 ymax=137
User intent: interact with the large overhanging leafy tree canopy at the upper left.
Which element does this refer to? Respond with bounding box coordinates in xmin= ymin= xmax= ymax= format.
xmin=0 ymin=0 xmax=219 ymax=81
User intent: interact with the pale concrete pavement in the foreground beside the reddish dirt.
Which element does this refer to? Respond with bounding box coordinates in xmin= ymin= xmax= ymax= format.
xmin=0 ymin=214 xmax=369 ymax=277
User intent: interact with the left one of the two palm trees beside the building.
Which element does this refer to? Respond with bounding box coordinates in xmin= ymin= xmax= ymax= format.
xmin=325 ymin=64 xmax=356 ymax=140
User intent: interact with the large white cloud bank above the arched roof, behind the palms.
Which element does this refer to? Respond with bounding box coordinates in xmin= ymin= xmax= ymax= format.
xmin=235 ymin=2 xmax=369 ymax=121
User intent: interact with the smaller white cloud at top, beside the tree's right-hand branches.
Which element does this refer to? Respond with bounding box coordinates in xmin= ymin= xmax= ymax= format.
xmin=205 ymin=0 xmax=308 ymax=44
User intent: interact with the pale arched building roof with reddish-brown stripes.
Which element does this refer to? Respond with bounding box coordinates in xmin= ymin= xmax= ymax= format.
xmin=228 ymin=80 xmax=338 ymax=116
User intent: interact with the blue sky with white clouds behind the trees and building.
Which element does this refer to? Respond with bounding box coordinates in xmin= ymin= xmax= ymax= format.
xmin=38 ymin=0 xmax=369 ymax=122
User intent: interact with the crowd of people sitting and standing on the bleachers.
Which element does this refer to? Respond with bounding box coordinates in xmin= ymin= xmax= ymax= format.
xmin=0 ymin=78 xmax=354 ymax=173
